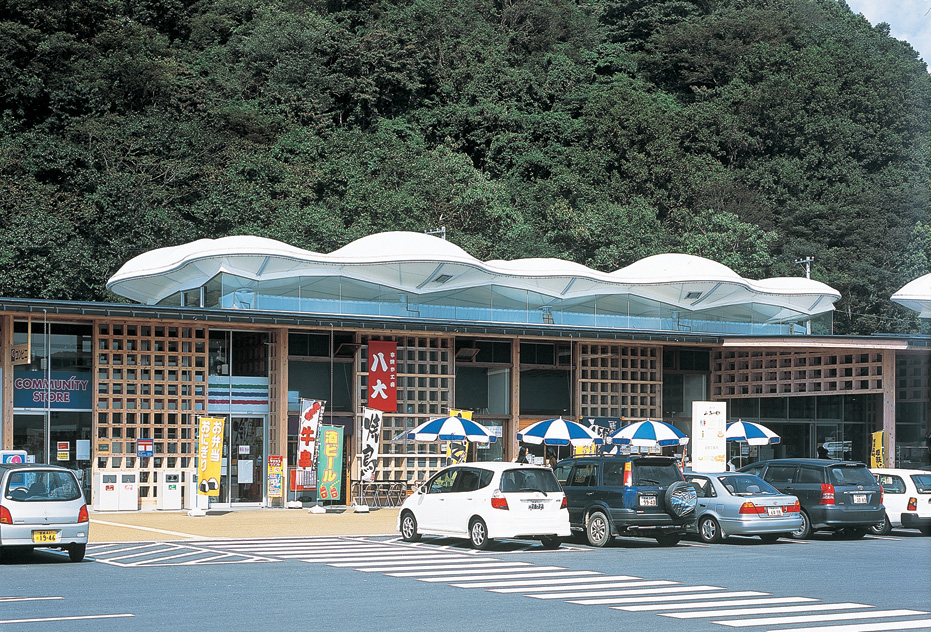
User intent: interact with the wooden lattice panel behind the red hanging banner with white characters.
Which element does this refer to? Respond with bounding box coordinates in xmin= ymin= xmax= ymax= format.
xmin=356 ymin=336 xmax=455 ymax=481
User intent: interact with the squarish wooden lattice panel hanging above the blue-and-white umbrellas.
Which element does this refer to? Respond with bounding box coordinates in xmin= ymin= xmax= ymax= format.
xmin=578 ymin=344 xmax=663 ymax=419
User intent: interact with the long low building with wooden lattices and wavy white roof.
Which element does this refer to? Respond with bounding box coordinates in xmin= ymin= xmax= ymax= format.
xmin=0 ymin=232 xmax=931 ymax=508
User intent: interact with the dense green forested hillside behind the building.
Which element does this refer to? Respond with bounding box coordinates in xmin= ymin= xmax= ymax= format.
xmin=0 ymin=0 xmax=931 ymax=333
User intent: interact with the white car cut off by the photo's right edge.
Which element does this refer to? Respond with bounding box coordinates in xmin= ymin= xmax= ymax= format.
xmin=870 ymin=468 xmax=931 ymax=536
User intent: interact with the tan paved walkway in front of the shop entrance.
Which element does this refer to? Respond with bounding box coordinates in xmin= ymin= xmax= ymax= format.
xmin=90 ymin=508 xmax=398 ymax=542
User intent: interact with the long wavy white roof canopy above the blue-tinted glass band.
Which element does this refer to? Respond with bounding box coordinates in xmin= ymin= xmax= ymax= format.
xmin=107 ymin=232 xmax=840 ymax=317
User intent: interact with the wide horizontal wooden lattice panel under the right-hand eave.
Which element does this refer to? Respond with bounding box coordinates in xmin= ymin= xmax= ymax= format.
xmin=711 ymin=349 xmax=883 ymax=398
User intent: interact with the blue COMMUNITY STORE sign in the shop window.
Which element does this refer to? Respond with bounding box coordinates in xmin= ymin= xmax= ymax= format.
xmin=13 ymin=371 xmax=94 ymax=410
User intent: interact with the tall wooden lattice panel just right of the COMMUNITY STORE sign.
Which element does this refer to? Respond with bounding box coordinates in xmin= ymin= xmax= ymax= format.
xmin=94 ymin=322 xmax=207 ymax=504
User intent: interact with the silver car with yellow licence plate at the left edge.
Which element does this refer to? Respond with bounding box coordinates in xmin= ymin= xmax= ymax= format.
xmin=0 ymin=464 xmax=89 ymax=562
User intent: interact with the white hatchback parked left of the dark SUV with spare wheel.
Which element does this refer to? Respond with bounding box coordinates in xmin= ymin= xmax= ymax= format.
xmin=398 ymin=462 xmax=570 ymax=549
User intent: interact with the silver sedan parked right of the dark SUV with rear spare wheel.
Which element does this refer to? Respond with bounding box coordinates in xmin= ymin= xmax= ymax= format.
xmin=685 ymin=472 xmax=802 ymax=542
